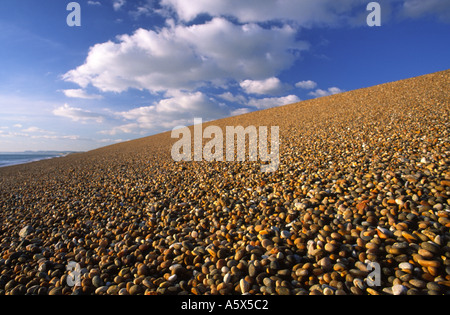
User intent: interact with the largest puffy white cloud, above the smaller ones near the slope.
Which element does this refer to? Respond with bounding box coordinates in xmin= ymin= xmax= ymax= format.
xmin=63 ymin=18 xmax=308 ymax=92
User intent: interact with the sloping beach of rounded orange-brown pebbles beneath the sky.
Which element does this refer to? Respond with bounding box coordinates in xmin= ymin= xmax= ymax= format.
xmin=0 ymin=70 xmax=450 ymax=295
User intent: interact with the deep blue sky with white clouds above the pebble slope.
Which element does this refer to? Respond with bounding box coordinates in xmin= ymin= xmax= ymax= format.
xmin=0 ymin=0 xmax=450 ymax=152
